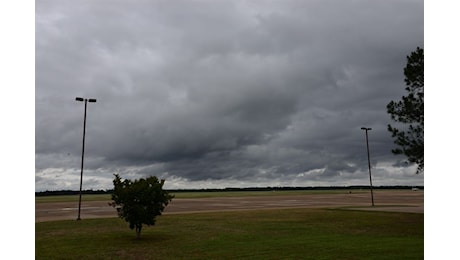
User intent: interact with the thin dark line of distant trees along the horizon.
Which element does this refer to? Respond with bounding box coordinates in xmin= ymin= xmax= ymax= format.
xmin=35 ymin=186 xmax=424 ymax=197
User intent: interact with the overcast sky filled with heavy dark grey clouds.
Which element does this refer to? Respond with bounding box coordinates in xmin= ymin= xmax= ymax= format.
xmin=35 ymin=0 xmax=424 ymax=191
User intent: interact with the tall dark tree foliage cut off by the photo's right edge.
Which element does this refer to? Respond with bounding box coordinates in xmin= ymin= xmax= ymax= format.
xmin=387 ymin=47 xmax=424 ymax=173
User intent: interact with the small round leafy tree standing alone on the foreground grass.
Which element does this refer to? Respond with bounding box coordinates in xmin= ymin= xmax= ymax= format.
xmin=110 ymin=174 xmax=174 ymax=238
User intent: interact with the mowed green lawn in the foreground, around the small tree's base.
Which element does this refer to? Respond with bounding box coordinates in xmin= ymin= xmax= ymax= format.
xmin=35 ymin=209 xmax=424 ymax=259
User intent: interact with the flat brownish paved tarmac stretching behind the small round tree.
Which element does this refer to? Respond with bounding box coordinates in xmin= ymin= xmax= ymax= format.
xmin=35 ymin=190 xmax=424 ymax=222
